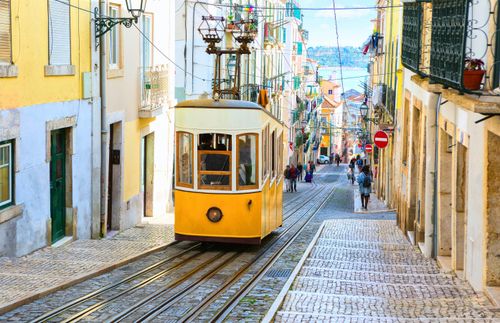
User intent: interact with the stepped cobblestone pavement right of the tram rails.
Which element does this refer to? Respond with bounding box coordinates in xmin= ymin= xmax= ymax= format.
xmin=274 ymin=219 xmax=500 ymax=322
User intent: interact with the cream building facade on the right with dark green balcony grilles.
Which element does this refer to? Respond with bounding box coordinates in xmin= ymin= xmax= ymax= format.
xmin=373 ymin=0 xmax=500 ymax=296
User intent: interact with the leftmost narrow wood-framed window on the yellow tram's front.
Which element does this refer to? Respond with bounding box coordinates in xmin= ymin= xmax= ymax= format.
xmin=177 ymin=132 xmax=193 ymax=187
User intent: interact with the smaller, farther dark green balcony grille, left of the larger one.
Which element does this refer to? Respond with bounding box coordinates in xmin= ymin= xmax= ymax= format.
xmin=402 ymin=2 xmax=422 ymax=73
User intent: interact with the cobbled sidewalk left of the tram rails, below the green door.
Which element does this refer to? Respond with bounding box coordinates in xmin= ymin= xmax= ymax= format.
xmin=0 ymin=223 xmax=174 ymax=314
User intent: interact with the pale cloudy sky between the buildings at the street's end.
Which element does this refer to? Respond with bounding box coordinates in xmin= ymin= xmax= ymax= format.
xmin=298 ymin=0 xmax=376 ymax=47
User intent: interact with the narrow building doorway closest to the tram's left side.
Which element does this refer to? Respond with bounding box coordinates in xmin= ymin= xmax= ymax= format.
xmin=141 ymin=133 xmax=154 ymax=217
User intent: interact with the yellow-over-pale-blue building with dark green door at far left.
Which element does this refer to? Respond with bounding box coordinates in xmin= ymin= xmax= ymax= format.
xmin=0 ymin=0 xmax=99 ymax=256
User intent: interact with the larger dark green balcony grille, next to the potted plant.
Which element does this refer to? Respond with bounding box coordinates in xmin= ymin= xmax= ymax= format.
xmin=431 ymin=0 xmax=470 ymax=89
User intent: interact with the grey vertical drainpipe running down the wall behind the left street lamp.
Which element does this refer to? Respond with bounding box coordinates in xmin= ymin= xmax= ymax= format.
xmin=99 ymin=0 xmax=108 ymax=237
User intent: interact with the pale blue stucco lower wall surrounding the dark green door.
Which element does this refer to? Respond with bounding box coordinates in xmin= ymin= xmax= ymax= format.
xmin=0 ymin=101 xmax=92 ymax=256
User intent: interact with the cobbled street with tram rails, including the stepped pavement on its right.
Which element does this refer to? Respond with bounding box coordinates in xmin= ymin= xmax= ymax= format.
xmin=0 ymin=165 xmax=500 ymax=322
